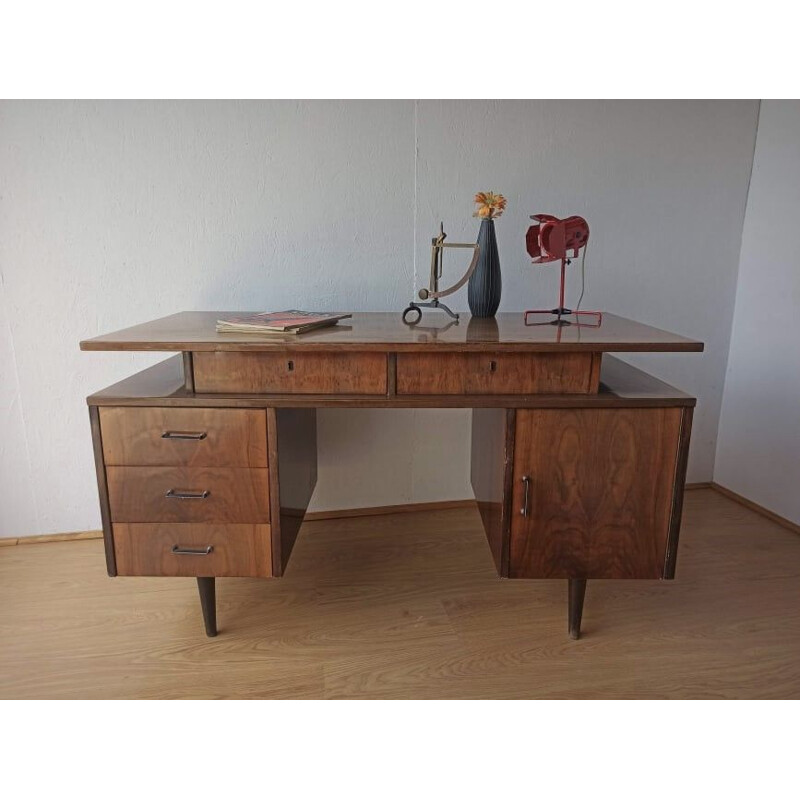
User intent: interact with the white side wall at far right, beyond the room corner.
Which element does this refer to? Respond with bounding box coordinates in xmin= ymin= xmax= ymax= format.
xmin=714 ymin=100 xmax=800 ymax=524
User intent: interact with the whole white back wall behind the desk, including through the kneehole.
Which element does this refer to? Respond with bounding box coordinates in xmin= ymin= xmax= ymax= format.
xmin=0 ymin=101 xmax=758 ymax=536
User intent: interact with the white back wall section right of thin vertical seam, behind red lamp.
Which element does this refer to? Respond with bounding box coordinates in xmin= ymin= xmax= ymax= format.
xmin=417 ymin=100 xmax=758 ymax=481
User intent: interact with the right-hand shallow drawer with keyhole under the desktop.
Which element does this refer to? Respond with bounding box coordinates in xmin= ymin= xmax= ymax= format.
xmin=397 ymin=353 xmax=600 ymax=394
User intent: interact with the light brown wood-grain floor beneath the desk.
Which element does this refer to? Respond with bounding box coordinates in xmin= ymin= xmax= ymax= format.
xmin=0 ymin=489 xmax=800 ymax=698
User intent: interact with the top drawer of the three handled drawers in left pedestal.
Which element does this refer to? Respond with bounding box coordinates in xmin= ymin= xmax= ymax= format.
xmin=100 ymin=407 xmax=267 ymax=467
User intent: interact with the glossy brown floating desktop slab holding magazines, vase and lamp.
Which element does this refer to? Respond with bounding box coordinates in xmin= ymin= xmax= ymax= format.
xmin=80 ymin=311 xmax=703 ymax=352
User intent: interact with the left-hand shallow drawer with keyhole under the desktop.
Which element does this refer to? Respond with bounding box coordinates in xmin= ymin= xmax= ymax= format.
xmin=192 ymin=351 xmax=386 ymax=394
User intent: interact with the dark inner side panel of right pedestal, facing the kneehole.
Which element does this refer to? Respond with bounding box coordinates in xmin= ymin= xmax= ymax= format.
xmin=470 ymin=408 xmax=515 ymax=575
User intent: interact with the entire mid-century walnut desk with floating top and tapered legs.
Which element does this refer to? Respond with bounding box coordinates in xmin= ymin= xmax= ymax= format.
xmin=81 ymin=312 xmax=703 ymax=638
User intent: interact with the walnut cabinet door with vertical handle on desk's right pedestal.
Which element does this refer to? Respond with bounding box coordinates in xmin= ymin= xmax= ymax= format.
xmin=509 ymin=408 xmax=683 ymax=578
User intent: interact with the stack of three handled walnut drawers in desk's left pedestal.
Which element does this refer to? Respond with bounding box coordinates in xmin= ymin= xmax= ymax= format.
xmin=100 ymin=406 xmax=272 ymax=577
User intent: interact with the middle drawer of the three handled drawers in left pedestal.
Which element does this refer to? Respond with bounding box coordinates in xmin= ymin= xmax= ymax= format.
xmin=106 ymin=467 xmax=269 ymax=523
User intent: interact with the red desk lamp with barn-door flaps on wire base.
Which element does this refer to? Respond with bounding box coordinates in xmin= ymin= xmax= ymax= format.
xmin=525 ymin=214 xmax=603 ymax=328
